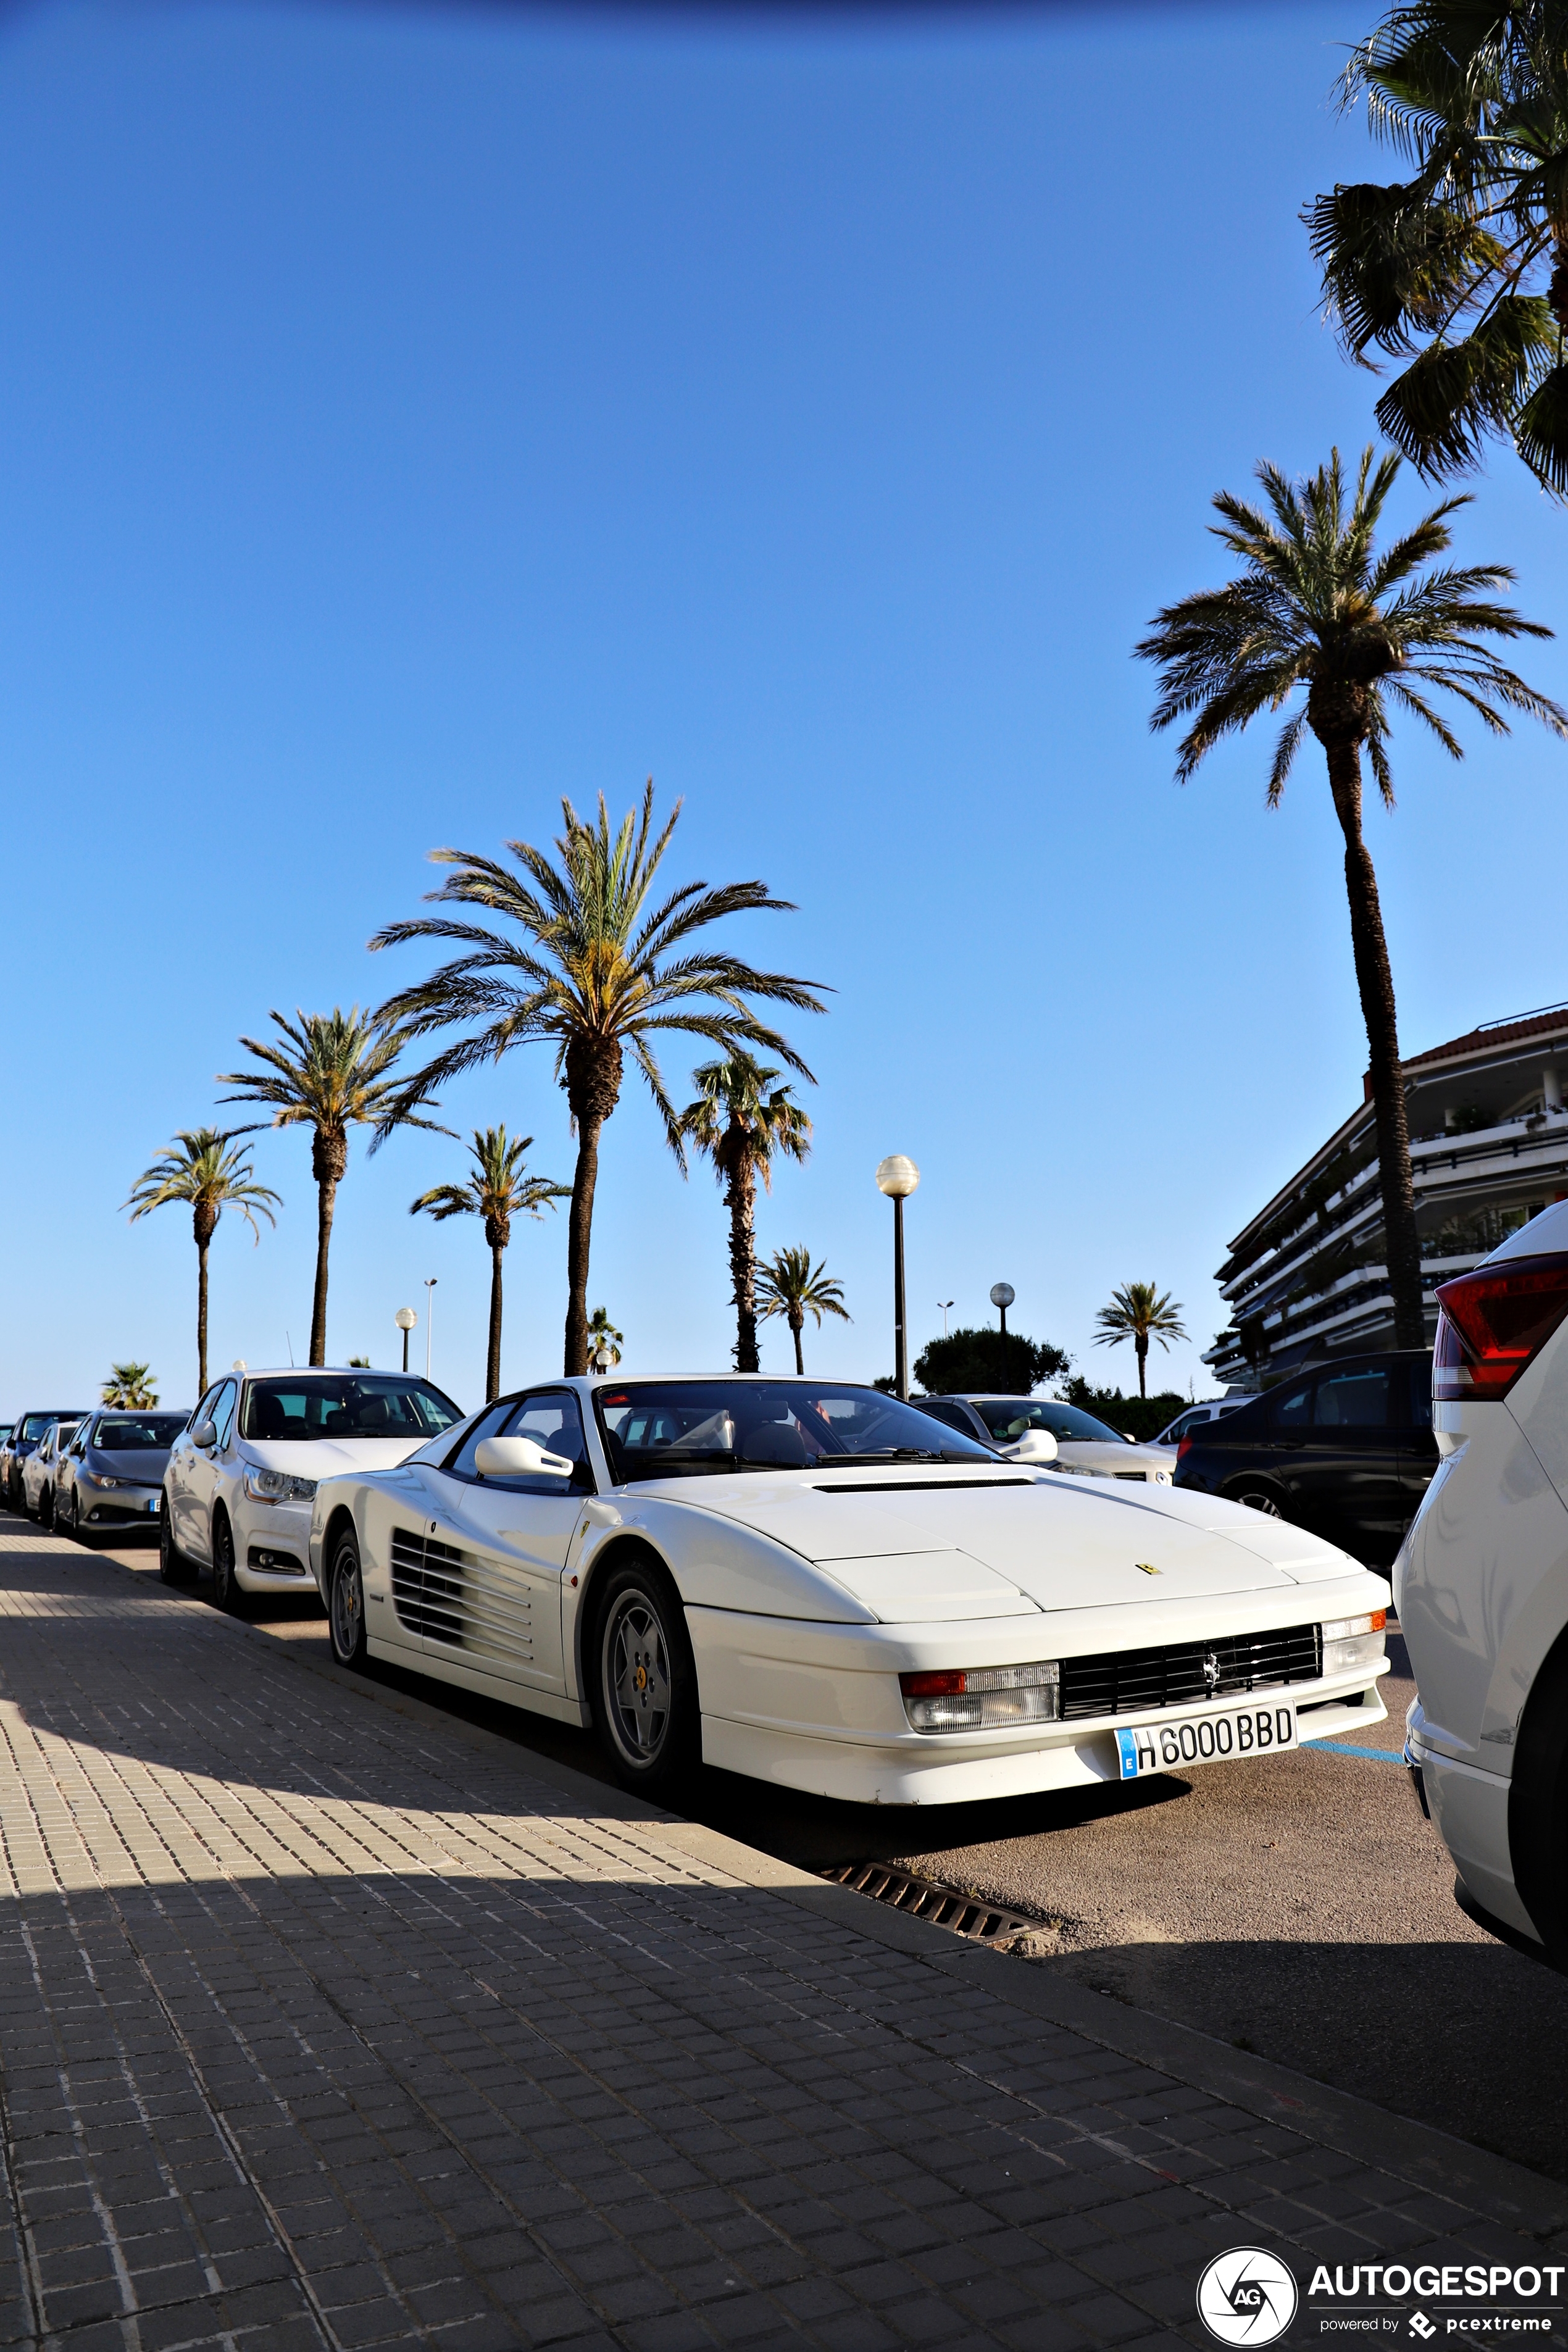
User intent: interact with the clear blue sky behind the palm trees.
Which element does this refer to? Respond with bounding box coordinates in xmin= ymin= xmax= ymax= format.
xmin=0 ymin=0 xmax=1568 ymax=1414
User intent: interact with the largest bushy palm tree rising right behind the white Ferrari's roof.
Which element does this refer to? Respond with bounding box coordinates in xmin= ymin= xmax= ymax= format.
xmin=372 ymin=781 xmax=823 ymax=1374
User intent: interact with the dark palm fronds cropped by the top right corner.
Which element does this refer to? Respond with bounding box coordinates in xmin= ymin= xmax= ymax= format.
xmin=1307 ymin=0 xmax=1568 ymax=496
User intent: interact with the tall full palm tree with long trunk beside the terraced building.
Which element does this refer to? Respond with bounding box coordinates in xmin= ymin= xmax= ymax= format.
xmin=1138 ymin=449 xmax=1568 ymax=1348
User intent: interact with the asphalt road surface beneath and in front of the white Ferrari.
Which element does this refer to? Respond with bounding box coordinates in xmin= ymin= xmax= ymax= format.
xmin=33 ymin=1514 xmax=1568 ymax=2180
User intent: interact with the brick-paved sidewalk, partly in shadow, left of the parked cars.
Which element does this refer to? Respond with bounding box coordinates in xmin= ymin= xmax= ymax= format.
xmin=0 ymin=1522 xmax=1568 ymax=2352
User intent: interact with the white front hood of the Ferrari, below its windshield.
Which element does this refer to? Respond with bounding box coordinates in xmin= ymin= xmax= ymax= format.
xmin=672 ymin=1463 xmax=1356 ymax=1623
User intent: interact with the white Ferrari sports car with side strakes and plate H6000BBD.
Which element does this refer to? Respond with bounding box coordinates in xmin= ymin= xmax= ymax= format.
xmin=311 ymin=1374 xmax=1387 ymax=1804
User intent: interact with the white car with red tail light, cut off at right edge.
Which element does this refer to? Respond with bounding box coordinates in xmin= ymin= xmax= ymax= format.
xmin=1394 ymin=1202 xmax=1568 ymax=1966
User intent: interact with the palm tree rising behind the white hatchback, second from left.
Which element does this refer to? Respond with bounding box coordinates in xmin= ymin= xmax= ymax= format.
xmin=219 ymin=1004 xmax=447 ymax=1364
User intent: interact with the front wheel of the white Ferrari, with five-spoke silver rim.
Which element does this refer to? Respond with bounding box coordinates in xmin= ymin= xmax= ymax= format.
xmin=593 ymin=1557 xmax=701 ymax=1792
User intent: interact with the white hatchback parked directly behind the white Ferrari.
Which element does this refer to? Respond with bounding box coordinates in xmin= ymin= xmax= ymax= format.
xmin=157 ymin=1371 xmax=461 ymax=1609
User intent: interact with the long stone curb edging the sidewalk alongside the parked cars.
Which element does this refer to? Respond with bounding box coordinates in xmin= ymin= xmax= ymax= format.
xmin=52 ymin=1536 xmax=1568 ymax=2239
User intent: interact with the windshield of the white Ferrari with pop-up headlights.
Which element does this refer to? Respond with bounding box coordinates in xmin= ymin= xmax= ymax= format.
xmin=594 ymin=1380 xmax=997 ymax=1487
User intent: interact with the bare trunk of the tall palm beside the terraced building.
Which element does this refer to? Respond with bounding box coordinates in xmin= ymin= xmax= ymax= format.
xmin=1324 ymin=743 xmax=1427 ymax=1348
